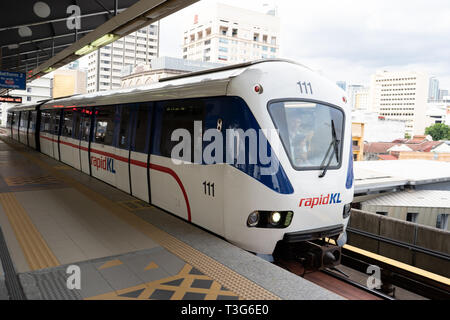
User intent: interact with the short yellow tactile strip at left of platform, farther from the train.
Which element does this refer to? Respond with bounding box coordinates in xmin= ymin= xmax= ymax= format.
xmin=0 ymin=193 xmax=60 ymax=270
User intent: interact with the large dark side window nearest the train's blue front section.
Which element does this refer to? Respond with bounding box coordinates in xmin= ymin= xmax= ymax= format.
xmin=160 ymin=100 xmax=205 ymax=162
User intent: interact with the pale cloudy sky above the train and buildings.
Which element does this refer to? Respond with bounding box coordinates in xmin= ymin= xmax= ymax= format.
xmin=160 ymin=0 xmax=450 ymax=90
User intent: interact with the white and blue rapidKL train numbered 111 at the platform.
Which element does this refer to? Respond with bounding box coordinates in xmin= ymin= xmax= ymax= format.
xmin=8 ymin=59 xmax=353 ymax=268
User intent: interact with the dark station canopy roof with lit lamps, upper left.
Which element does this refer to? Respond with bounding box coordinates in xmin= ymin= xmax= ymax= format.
xmin=0 ymin=0 xmax=198 ymax=92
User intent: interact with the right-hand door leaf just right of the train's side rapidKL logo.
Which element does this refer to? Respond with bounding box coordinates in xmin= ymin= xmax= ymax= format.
xmin=130 ymin=103 xmax=153 ymax=202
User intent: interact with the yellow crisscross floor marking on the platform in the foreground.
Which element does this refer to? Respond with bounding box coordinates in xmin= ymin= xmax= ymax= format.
xmin=86 ymin=264 xmax=243 ymax=300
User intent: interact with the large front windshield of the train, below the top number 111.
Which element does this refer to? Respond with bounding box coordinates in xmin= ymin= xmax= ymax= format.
xmin=269 ymin=101 xmax=344 ymax=170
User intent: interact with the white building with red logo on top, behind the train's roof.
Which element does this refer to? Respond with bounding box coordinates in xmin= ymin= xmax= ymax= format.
xmin=183 ymin=3 xmax=280 ymax=64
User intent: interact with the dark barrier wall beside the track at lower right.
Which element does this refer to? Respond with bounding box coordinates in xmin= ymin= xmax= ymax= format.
xmin=348 ymin=210 xmax=450 ymax=277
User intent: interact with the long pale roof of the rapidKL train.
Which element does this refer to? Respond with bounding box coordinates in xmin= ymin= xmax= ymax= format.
xmin=10 ymin=59 xmax=309 ymax=111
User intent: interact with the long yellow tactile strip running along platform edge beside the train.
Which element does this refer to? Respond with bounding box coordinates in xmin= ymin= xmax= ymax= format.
xmin=2 ymin=139 xmax=280 ymax=300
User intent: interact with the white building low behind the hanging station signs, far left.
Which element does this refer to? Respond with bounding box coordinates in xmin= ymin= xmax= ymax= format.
xmin=0 ymin=74 xmax=53 ymax=127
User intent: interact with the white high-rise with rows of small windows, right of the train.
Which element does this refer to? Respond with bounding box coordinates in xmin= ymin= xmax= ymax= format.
xmin=369 ymin=71 xmax=429 ymax=137
